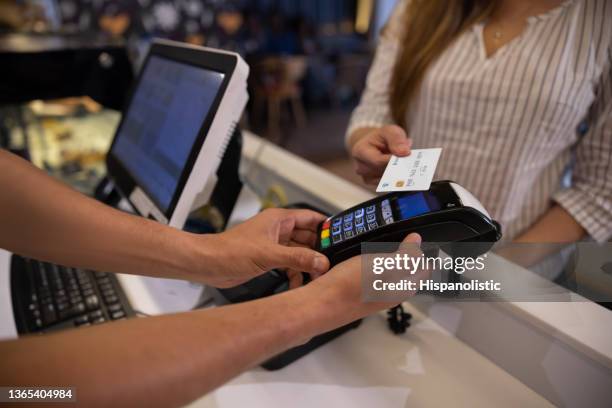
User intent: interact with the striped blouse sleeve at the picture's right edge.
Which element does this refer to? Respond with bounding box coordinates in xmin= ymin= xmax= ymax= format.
xmin=554 ymin=50 xmax=612 ymax=242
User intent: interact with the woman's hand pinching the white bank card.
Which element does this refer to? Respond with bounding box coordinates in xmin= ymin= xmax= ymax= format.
xmin=349 ymin=125 xmax=412 ymax=185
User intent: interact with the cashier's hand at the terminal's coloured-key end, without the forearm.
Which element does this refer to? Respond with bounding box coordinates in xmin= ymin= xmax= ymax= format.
xmin=204 ymin=208 xmax=329 ymax=288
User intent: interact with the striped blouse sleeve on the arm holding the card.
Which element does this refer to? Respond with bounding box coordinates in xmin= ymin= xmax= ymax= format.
xmin=346 ymin=0 xmax=409 ymax=140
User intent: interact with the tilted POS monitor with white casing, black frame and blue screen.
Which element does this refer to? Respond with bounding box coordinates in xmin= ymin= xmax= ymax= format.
xmin=106 ymin=41 xmax=249 ymax=228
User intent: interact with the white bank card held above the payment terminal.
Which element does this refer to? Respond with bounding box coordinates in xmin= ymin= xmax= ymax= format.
xmin=376 ymin=147 xmax=442 ymax=193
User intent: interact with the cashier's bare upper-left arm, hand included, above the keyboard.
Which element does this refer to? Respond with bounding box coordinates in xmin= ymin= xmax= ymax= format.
xmin=0 ymin=149 xmax=329 ymax=287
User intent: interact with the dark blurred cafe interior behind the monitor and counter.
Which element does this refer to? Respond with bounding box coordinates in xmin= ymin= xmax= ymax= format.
xmin=0 ymin=0 xmax=396 ymax=192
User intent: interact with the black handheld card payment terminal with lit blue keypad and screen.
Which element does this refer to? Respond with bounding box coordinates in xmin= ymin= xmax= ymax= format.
xmin=316 ymin=181 xmax=501 ymax=265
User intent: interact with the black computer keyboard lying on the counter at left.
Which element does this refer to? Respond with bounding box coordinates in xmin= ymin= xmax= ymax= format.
xmin=11 ymin=255 xmax=134 ymax=334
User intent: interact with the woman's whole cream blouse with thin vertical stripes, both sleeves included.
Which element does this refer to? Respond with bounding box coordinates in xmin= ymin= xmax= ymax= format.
xmin=347 ymin=0 xmax=612 ymax=241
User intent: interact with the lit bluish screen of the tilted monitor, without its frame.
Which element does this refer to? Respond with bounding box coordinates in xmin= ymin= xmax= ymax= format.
xmin=111 ymin=56 xmax=225 ymax=213
